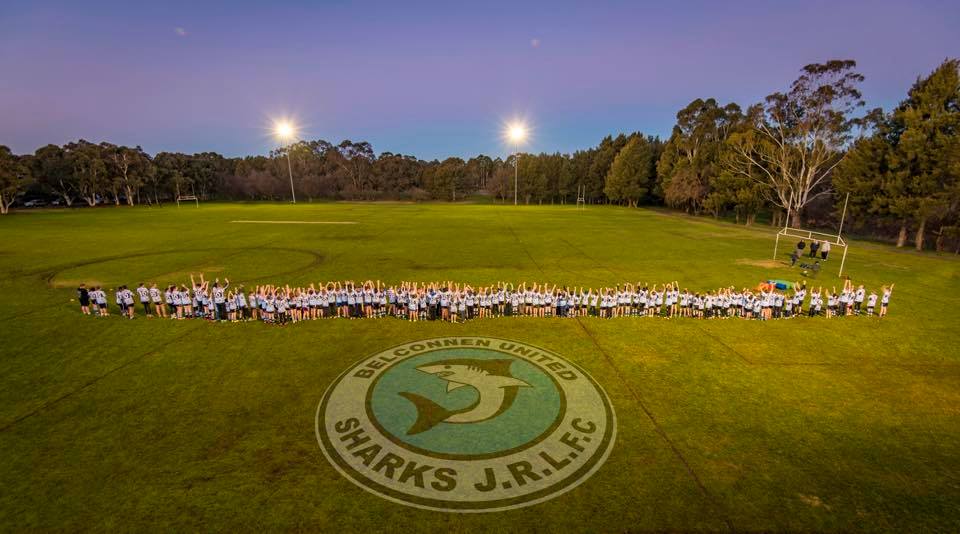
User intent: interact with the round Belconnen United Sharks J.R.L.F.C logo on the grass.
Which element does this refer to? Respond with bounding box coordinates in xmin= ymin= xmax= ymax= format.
xmin=316 ymin=337 xmax=616 ymax=512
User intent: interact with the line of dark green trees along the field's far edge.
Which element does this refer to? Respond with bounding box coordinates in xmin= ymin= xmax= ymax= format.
xmin=0 ymin=59 xmax=960 ymax=250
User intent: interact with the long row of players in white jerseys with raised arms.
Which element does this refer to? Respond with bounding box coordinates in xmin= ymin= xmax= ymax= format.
xmin=77 ymin=275 xmax=893 ymax=325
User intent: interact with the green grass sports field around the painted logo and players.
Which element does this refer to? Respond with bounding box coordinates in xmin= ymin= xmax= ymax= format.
xmin=0 ymin=204 xmax=960 ymax=532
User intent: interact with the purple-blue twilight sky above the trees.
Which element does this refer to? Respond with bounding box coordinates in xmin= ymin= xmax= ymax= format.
xmin=0 ymin=0 xmax=960 ymax=159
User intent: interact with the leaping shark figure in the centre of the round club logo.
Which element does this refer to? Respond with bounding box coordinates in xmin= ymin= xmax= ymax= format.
xmin=400 ymin=358 xmax=531 ymax=436
